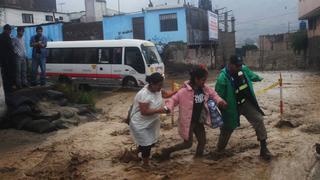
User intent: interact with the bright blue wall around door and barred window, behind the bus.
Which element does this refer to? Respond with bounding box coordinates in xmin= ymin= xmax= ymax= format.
xmin=103 ymin=8 xmax=187 ymax=44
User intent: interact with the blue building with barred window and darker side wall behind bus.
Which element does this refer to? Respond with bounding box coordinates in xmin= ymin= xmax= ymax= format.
xmin=103 ymin=6 xmax=209 ymax=45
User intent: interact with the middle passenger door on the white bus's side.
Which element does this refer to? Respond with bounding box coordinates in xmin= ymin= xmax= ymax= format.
xmin=96 ymin=48 xmax=114 ymax=84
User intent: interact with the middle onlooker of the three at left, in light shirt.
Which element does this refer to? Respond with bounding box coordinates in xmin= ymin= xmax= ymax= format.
xmin=12 ymin=27 xmax=27 ymax=89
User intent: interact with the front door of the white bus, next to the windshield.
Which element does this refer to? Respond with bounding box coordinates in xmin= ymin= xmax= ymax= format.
xmin=124 ymin=47 xmax=146 ymax=84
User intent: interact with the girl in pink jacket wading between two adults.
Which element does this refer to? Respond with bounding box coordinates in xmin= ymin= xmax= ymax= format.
xmin=160 ymin=67 xmax=227 ymax=159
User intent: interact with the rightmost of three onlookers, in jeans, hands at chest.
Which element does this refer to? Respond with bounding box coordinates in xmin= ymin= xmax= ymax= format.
xmin=30 ymin=26 xmax=48 ymax=86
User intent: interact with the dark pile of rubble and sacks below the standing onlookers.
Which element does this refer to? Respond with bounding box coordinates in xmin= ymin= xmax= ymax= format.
xmin=0 ymin=88 xmax=96 ymax=133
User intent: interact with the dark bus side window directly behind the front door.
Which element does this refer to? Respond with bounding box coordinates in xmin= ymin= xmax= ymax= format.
xmin=99 ymin=47 xmax=122 ymax=64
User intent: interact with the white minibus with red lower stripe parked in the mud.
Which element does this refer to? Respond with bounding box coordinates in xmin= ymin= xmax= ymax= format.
xmin=47 ymin=39 xmax=164 ymax=86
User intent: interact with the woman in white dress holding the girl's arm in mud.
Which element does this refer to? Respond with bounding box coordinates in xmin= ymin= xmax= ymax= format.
xmin=129 ymin=73 xmax=174 ymax=166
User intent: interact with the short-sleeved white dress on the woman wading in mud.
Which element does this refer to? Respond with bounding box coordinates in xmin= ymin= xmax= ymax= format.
xmin=130 ymin=85 xmax=163 ymax=146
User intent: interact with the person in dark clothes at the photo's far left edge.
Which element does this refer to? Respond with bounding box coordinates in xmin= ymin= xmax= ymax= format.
xmin=0 ymin=24 xmax=16 ymax=94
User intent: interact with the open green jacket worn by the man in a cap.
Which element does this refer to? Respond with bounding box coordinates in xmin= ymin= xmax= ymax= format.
xmin=215 ymin=65 xmax=264 ymax=130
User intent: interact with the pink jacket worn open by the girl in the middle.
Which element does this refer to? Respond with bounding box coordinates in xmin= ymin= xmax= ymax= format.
xmin=166 ymin=82 xmax=222 ymax=140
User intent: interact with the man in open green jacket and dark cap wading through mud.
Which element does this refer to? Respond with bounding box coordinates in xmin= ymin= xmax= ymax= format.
xmin=215 ymin=56 xmax=272 ymax=160
